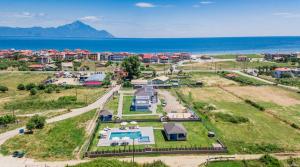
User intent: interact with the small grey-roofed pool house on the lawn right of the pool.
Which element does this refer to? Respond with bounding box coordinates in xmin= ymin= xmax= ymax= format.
xmin=164 ymin=122 xmax=187 ymax=141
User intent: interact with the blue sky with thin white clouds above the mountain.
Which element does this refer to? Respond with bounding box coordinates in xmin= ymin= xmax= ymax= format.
xmin=0 ymin=0 xmax=300 ymax=38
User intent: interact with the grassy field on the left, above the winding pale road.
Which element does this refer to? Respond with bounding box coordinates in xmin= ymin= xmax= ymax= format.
xmin=0 ymin=72 xmax=106 ymax=114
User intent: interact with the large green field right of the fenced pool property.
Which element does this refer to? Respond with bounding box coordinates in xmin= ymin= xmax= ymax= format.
xmin=180 ymin=87 xmax=300 ymax=153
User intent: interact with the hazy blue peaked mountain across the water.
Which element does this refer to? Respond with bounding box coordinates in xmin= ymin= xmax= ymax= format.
xmin=0 ymin=21 xmax=114 ymax=39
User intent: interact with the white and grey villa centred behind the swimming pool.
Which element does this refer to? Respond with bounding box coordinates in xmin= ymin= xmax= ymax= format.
xmin=131 ymin=85 xmax=158 ymax=111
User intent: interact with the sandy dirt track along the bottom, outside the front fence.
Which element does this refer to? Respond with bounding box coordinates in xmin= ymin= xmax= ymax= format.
xmin=0 ymin=152 xmax=300 ymax=167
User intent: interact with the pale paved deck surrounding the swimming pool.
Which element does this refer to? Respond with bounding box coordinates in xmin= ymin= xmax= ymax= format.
xmin=97 ymin=127 xmax=155 ymax=147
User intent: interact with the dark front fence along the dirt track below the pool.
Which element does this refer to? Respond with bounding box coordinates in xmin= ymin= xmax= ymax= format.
xmin=84 ymin=147 xmax=228 ymax=158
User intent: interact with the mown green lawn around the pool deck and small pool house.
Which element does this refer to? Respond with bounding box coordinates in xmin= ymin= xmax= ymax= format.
xmin=90 ymin=122 xmax=215 ymax=151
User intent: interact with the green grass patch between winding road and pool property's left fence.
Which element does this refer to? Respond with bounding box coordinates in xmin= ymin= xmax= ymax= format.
xmin=1 ymin=110 xmax=95 ymax=160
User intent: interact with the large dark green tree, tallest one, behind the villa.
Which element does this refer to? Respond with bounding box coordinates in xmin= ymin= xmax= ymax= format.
xmin=121 ymin=56 xmax=141 ymax=80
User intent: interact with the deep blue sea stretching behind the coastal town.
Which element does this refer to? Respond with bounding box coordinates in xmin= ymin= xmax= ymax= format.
xmin=0 ymin=37 xmax=300 ymax=54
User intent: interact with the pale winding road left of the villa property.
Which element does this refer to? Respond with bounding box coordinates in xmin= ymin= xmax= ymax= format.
xmin=0 ymin=85 xmax=121 ymax=145
